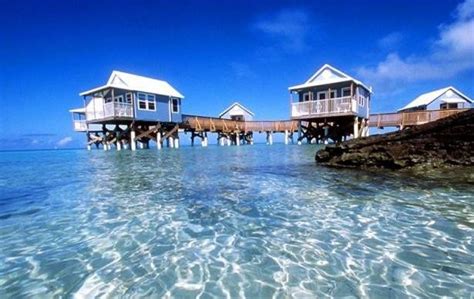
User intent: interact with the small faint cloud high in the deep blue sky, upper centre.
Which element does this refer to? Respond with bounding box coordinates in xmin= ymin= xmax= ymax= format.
xmin=252 ymin=9 xmax=311 ymax=52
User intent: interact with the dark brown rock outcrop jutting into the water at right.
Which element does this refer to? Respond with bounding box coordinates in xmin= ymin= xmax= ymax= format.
xmin=316 ymin=109 xmax=474 ymax=169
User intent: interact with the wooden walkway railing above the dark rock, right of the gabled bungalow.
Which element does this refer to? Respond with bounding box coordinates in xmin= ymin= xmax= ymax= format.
xmin=369 ymin=109 xmax=466 ymax=128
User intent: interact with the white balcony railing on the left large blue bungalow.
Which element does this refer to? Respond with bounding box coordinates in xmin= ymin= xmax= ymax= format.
xmin=86 ymin=98 xmax=133 ymax=121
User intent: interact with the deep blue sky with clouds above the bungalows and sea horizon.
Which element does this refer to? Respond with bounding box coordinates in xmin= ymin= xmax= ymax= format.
xmin=0 ymin=0 xmax=474 ymax=149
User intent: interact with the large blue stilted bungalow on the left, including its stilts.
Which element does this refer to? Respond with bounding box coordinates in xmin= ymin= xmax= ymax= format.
xmin=70 ymin=71 xmax=184 ymax=150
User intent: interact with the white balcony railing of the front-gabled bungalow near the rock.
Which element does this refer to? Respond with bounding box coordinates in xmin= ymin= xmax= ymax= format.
xmin=291 ymin=97 xmax=358 ymax=117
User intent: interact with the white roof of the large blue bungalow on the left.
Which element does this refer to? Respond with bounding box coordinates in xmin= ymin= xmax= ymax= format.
xmin=80 ymin=71 xmax=184 ymax=99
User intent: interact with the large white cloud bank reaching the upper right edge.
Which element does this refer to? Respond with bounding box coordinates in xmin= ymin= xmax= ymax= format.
xmin=358 ymin=0 xmax=474 ymax=95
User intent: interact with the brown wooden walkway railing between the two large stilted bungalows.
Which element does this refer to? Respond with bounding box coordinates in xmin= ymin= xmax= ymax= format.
xmin=183 ymin=115 xmax=298 ymax=132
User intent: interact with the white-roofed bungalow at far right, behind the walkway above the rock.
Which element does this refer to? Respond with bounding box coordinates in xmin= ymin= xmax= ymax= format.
xmin=398 ymin=86 xmax=473 ymax=112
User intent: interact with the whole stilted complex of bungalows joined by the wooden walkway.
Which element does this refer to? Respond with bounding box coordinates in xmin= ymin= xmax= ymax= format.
xmin=70 ymin=64 xmax=472 ymax=151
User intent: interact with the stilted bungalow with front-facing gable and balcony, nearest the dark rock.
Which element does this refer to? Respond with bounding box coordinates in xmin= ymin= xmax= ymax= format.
xmin=288 ymin=64 xmax=372 ymax=141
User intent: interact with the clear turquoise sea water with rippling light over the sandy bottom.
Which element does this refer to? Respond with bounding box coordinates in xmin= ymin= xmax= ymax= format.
xmin=0 ymin=145 xmax=474 ymax=298
